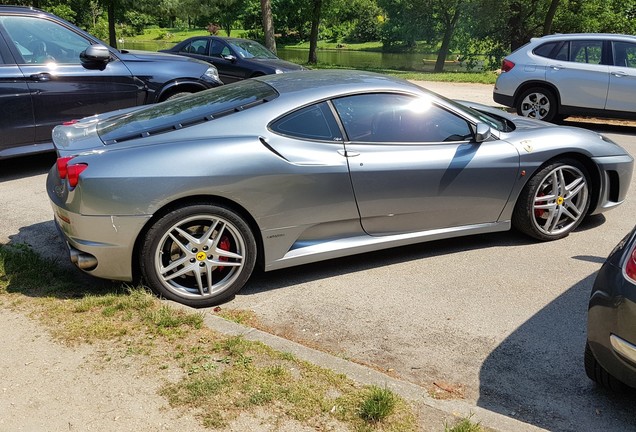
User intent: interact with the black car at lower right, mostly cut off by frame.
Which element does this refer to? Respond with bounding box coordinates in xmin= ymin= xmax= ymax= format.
xmin=585 ymin=227 xmax=636 ymax=391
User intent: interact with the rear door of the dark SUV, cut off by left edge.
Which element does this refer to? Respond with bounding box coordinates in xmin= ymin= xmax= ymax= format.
xmin=0 ymin=31 xmax=35 ymax=158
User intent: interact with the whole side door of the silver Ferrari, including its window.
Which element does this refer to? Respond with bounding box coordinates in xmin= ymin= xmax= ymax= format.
xmin=333 ymin=93 xmax=519 ymax=235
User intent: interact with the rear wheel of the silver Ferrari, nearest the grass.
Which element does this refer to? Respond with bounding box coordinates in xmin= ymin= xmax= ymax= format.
xmin=139 ymin=203 xmax=256 ymax=307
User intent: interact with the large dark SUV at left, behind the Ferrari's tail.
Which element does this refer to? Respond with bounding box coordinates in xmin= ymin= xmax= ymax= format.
xmin=0 ymin=6 xmax=222 ymax=159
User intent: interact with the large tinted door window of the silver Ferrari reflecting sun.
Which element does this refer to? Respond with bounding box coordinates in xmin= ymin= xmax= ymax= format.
xmin=333 ymin=93 xmax=472 ymax=143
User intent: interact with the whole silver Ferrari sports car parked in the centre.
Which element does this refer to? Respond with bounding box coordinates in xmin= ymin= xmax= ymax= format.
xmin=47 ymin=70 xmax=633 ymax=307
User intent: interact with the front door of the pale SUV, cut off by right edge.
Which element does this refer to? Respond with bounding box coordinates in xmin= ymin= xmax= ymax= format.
xmin=605 ymin=41 xmax=636 ymax=112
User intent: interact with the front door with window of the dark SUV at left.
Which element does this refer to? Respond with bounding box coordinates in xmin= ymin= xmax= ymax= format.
xmin=0 ymin=15 xmax=145 ymax=143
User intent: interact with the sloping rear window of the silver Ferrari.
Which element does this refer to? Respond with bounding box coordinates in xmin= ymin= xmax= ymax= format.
xmin=97 ymin=80 xmax=278 ymax=144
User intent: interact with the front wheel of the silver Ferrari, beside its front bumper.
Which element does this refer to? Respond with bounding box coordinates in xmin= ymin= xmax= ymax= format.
xmin=512 ymin=159 xmax=590 ymax=241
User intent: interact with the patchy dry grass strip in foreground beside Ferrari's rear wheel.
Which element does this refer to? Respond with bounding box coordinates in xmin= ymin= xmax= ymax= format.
xmin=0 ymin=245 xmax=418 ymax=432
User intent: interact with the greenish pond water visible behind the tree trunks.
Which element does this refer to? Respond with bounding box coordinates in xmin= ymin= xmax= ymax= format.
xmin=119 ymin=41 xmax=466 ymax=72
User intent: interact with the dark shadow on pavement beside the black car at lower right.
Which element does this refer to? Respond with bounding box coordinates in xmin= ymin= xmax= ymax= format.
xmin=477 ymin=272 xmax=636 ymax=432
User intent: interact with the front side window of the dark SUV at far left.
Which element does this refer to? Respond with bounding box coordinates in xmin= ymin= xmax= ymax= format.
xmin=0 ymin=16 xmax=90 ymax=64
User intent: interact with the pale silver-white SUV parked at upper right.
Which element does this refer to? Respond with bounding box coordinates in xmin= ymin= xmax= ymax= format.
xmin=493 ymin=33 xmax=636 ymax=121
